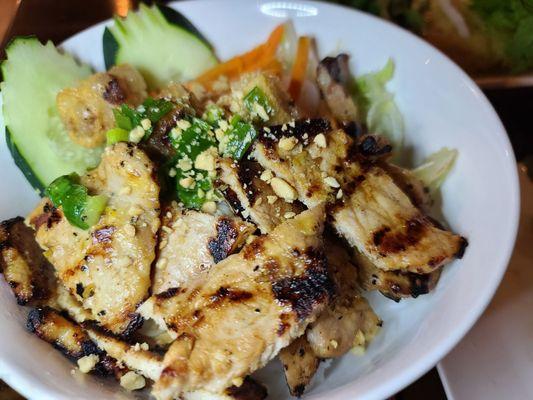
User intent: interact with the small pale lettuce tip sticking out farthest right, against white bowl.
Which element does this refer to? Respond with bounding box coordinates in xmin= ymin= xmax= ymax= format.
xmin=412 ymin=147 xmax=458 ymax=193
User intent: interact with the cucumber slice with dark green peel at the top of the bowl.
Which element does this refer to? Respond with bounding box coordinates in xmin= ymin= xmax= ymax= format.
xmin=102 ymin=3 xmax=218 ymax=89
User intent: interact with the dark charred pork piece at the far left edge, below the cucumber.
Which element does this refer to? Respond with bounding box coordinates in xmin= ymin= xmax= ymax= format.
xmin=0 ymin=217 xmax=55 ymax=305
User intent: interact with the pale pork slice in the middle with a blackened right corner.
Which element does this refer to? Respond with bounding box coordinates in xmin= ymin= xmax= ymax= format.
xmin=139 ymin=207 xmax=255 ymax=336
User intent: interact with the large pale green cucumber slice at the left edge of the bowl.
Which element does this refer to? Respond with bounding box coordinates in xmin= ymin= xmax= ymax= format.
xmin=0 ymin=37 xmax=102 ymax=193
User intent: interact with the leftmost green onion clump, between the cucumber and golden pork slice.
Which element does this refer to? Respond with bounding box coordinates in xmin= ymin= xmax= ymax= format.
xmin=46 ymin=173 xmax=107 ymax=229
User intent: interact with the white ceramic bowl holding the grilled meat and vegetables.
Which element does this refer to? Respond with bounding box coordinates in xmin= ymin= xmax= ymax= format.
xmin=0 ymin=0 xmax=519 ymax=400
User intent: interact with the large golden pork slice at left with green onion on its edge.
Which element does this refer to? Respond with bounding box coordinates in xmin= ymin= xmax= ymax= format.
xmin=28 ymin=143 xmax=160 ymax=335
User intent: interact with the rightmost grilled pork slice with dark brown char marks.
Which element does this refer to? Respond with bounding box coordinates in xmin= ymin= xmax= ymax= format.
xmin=331 ymin=167 xmax=465 ymax=273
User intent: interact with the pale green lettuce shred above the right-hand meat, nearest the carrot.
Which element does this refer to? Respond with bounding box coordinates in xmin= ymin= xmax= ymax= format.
xmin=354 ymin=59 xmax=405 ymax=154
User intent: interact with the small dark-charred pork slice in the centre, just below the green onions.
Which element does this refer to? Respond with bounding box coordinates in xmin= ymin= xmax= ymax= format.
xmin=219 ymin=158 xmax=304 ymax=233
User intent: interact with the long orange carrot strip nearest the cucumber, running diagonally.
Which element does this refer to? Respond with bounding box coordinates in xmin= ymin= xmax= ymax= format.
xmin=195 ymin=25 xmax=285 ymax=87
